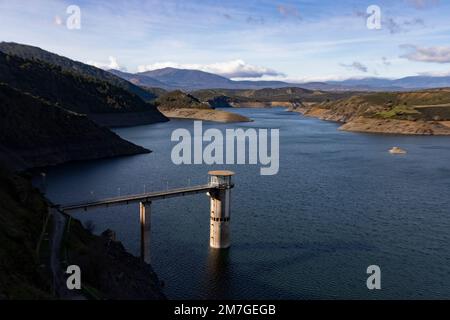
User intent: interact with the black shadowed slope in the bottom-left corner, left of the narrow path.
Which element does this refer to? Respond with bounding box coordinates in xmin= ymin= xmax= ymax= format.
xmin=0 ymin=164 xmax=52 ymax=300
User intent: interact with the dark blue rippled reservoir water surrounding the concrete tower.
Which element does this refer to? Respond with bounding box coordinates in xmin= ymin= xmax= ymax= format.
xmin=47 ymin=108 xmax=450 ymax=299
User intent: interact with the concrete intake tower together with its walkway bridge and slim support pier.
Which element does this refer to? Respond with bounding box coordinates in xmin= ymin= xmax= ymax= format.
xmin=56 ymin=170 xmax=234 ymax=261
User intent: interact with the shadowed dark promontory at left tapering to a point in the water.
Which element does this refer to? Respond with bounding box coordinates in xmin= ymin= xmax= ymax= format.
xmin=0 ymin=84 xmax=149 ymax=169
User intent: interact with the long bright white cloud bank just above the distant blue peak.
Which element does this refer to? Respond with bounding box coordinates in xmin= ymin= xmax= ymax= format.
xmin=138 ymin=59 xmax=283 ymax=78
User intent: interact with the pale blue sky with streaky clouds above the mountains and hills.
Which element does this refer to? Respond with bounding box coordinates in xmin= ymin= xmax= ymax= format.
xmin=0 ymin=0 xmax=450 ymax=81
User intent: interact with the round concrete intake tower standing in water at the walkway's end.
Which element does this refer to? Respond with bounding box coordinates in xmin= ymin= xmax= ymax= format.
xmin=208 ymin=171 xmax=234 ymax=249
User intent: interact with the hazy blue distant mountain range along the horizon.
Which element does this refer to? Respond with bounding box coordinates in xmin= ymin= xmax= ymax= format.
xmin=109 ymin=68 xmax=450 ymax=91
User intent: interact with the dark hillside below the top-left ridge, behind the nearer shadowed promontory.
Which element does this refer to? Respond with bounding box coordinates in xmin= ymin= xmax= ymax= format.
xmin=0 ymin=52 xmax=166 ymax=126
